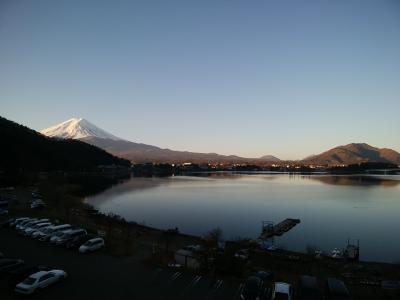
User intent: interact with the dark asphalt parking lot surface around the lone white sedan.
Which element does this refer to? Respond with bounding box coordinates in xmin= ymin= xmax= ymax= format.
xmin=0 ymin=229 xmax=250 ymax=300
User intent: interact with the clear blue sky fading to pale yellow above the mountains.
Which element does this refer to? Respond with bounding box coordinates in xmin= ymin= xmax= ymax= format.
xmin=0 ymin=0 xmax=400 ymax=159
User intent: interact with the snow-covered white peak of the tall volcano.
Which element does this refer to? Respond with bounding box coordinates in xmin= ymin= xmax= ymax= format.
xmin=40 ymin=118 xmax=122 ymax=141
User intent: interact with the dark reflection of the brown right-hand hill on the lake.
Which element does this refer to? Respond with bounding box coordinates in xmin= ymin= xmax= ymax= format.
xmin=310 ymin=175 xmax=400 ymax=187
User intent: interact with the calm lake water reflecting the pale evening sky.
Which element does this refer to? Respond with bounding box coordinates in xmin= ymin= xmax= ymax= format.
xmin=86 ymin=173 xmax=400 ymax=262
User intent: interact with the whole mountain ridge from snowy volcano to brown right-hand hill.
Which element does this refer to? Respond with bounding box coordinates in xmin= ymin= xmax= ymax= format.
xmin=41 ymin=118 xmax=400 ymax=166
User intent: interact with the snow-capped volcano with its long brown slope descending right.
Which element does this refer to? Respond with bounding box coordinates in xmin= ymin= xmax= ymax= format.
xmin=40 ymin=118 xmax=279 ymax=163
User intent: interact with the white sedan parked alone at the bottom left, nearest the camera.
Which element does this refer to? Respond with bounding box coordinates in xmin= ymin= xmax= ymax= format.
xmin=14 ymin=270 xmax=67 ymax=294
